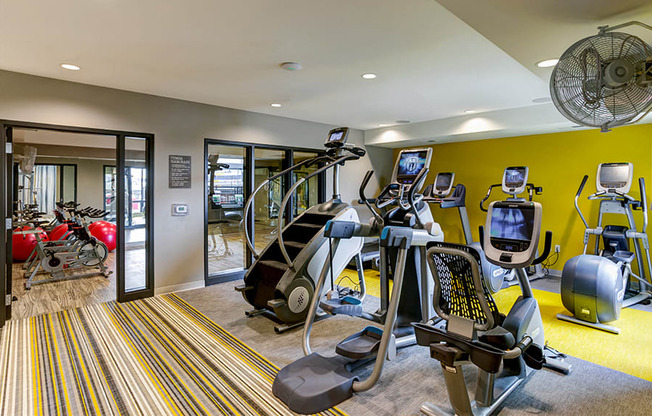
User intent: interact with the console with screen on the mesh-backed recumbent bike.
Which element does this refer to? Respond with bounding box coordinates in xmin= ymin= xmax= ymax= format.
xmin=484 ymin=201 xmax=542 ymax=268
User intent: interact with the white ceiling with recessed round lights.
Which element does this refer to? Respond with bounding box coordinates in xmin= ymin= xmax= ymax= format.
xmin=0 ymin=0 xmax=652 ymax=146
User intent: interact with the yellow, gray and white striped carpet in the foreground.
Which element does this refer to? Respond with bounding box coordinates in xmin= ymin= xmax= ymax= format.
xmin=0 ymin=294 xmax=344 ymax=416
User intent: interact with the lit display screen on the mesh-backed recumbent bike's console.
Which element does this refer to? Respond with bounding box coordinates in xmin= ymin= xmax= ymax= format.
xmin=489 ymin=206 xmax=534 ymax=251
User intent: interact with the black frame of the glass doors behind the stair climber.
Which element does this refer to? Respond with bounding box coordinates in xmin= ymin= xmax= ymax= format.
xmin=204 ymin=138 xmax=326 ymax=286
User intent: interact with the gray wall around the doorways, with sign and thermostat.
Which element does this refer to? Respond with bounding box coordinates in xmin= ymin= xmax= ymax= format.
xmin=0 ymin=71 xmax=393 ymax=292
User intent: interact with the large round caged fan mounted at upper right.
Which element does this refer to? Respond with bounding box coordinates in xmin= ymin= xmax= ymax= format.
xmin=550 ymin=22 xmax=652 ymax=131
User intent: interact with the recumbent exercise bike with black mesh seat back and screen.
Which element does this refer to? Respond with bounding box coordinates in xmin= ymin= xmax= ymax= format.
xmin=414 ymin=199 xmax=571 ymax=416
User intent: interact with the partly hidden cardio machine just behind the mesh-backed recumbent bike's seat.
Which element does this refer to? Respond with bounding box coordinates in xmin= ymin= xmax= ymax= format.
xmin=423 ymin=172 xmax=514 ymax=293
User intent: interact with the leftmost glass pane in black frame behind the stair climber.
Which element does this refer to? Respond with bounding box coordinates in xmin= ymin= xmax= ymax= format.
xmin=206 ymin=144 xmax=248 ymax=277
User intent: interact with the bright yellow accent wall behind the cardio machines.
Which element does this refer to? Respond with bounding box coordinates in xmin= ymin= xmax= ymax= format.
xmin=394 ymin=124 xmax=652 ymax=270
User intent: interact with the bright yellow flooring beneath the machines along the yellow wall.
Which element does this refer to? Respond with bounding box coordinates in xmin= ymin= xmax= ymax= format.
xmin=338 ymin=270 xmax=652 ymax=381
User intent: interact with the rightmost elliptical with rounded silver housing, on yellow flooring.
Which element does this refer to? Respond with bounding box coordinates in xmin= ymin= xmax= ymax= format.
xmin=557 ymin=163 xmax=652 ymax=334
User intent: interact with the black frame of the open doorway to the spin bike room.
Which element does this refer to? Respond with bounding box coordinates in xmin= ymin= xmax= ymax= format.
xmin=0 ymin=120 xmax=154 ymax=327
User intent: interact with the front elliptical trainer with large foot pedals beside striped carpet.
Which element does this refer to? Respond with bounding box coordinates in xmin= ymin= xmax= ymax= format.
xmin=272 ymin=149 xmax=444 ymax=414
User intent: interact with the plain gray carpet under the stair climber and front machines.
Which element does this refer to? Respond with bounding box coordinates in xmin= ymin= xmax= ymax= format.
xmin=178 ymin=281 xmax=652 ymax=416
